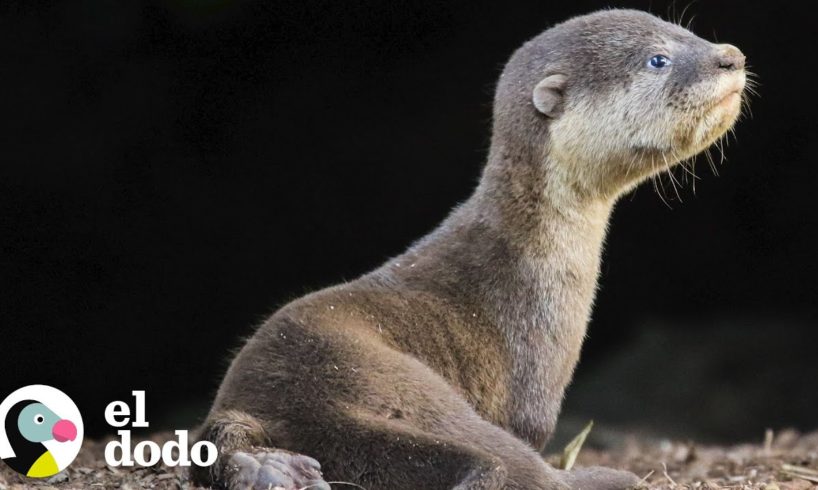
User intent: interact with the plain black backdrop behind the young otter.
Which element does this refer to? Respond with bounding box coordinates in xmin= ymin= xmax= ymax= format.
xmin=0 ymin=0 xmax=818 ymax=440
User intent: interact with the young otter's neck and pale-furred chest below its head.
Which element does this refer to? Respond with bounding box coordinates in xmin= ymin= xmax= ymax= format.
xmin=443 ymin=137 xmax=614 ymax=447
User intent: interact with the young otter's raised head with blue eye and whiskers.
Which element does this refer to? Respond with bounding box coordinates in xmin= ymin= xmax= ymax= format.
xmin=488 ymin=10 xmax=746 ymax=197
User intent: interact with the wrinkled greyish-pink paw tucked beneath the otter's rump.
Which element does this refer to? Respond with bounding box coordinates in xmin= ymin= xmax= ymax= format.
xmin=227 ymin=450 xmax=330 ymax=490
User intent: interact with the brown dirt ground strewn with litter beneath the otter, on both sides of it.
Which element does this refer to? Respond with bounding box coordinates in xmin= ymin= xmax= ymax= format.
xmin=0 ymin=431 xmax=818 ymax=490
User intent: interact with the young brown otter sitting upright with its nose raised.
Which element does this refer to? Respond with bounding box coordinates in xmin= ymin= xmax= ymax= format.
xmin=195 ymin=10 xmax=746 ymax=490
